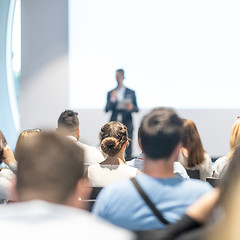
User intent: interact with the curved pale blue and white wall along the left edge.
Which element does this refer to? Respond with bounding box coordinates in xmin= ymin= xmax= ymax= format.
xmin=0 ymin=0 xmax=20 ymax=148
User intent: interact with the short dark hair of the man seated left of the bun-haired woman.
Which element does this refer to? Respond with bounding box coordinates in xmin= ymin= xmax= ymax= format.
xmin=58 ymin=110 xmax=79 ymax=131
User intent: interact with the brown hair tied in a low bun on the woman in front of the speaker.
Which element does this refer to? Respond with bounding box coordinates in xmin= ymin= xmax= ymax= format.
xmin=100 ymin=122 xmax=128 ymax=157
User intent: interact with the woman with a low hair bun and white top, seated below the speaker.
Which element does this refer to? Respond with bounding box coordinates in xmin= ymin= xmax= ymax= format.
xmin=86 ymin=122 xmax=140 ymax=187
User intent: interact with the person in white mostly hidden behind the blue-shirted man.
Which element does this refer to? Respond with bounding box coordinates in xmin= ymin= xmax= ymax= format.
xmin=126 ymin=129 xmax=189 ymax=179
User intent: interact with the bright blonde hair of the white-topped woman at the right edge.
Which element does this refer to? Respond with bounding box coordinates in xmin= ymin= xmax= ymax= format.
xmin=227 ymin=118 xmax=240 ymax=160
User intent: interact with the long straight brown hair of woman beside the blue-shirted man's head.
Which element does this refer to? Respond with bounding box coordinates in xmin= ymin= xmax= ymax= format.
xmin=182 ymin=119 xmax=205 ymax=168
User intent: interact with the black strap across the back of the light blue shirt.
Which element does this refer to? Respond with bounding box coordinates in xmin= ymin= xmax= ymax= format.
xmin=131 ymin=178 xmax=169 ymax=225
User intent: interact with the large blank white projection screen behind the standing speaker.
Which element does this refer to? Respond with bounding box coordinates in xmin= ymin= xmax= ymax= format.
xmin=69 ymin=0 xmax=240 ymax=109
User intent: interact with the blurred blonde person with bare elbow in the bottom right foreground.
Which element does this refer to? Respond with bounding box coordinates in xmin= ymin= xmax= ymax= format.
xmin=144 ymin=146 xmax=240 ymax=240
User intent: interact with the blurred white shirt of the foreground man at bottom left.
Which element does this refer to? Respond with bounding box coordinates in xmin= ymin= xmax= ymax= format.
xmin=0 ymin=200 xmax=135 ymax=240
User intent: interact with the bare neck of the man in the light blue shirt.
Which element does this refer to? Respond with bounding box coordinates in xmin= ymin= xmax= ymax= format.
xmin=144 ymin=157 xmax=175 ymax=178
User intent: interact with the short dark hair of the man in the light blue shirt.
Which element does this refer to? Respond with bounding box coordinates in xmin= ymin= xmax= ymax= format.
xmin=139 ymin=108 xmax=183 ymax=159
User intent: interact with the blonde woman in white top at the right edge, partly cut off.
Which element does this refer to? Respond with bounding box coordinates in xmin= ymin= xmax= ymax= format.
xmin=212 ymin=117 xmax=240 ymax=178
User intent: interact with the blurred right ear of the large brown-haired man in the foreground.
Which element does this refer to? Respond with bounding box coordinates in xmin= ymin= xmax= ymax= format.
xmin=71 ymin=178 xmax=92 ymax=209
